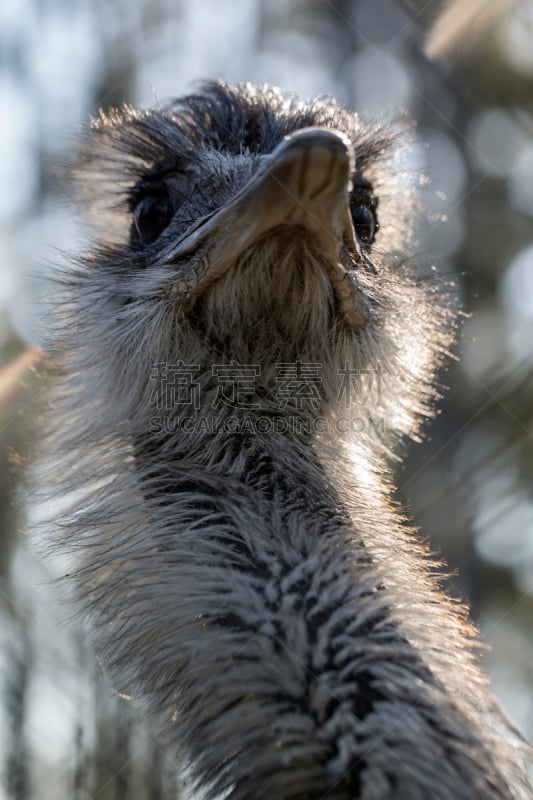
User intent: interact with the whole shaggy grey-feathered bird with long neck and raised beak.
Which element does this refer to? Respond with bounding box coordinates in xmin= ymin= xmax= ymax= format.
xmin=44 ymin=83 xmax=530 ymax=800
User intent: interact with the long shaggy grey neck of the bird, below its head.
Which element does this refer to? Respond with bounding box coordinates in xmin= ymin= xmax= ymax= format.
xmin=54 ymin=404 xmax=524 ymax=800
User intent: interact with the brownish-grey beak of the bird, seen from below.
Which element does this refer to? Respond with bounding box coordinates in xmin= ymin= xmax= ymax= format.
xmin=164 ymin=128 xmax=360 ymax=314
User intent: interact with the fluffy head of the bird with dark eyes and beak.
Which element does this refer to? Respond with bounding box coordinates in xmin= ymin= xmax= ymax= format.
xmin=70 ymin=83 xmax=442 ymax=450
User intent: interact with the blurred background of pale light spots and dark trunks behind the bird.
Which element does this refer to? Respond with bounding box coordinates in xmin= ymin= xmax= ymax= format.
xmin=0 ymin=0 xmax=533 ymax=800
